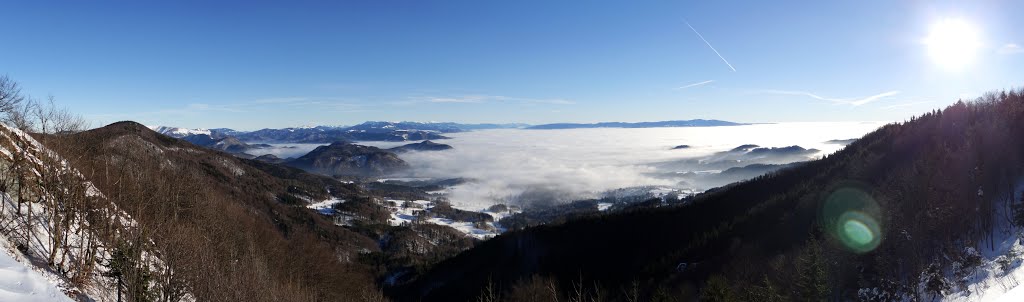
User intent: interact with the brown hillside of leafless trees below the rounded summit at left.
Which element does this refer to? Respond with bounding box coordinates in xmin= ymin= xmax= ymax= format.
xmin=63 ymin=122 xmax=387 ymax=301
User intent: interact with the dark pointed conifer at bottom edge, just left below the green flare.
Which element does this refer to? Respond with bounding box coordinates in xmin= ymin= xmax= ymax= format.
xmin=797 ymin=240 xmax=830 ymax=301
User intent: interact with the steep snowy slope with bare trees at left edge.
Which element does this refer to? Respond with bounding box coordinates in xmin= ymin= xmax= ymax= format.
xmin=0 ymin=124 xmax=190 ymax=302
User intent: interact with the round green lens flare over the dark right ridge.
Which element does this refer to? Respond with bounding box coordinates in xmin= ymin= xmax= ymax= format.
xmin=821 ymin=186 xmax=882 ymax=254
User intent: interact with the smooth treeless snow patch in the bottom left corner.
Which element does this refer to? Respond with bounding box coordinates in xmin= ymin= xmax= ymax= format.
xmin=0 ymin=240 xmax=74 ymax=302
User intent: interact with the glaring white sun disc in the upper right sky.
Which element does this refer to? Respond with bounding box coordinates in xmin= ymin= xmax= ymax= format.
xmin=925 ymin=18 xmax=981 ymax=71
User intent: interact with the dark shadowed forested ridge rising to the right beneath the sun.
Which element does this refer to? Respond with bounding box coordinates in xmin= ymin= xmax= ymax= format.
xmin=390 ymin=90 xmax=1024 ymax=301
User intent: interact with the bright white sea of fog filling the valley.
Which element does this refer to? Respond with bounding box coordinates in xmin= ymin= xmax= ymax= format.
xmin=358 ymin=123 xmax=882 ymax=209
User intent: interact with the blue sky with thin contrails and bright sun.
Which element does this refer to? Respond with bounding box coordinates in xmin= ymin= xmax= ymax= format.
xmin=0 ymin=0 xmax=1024 ymax=130
